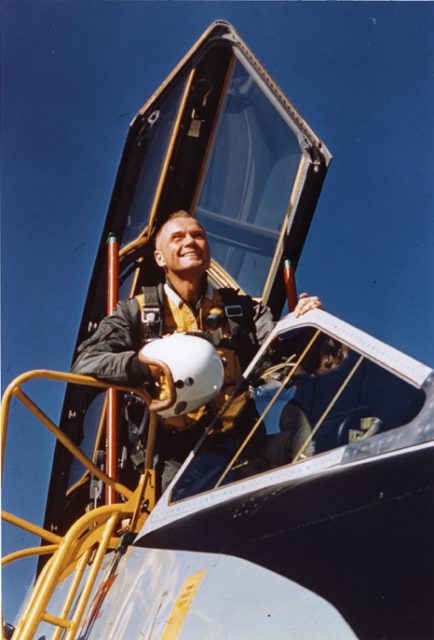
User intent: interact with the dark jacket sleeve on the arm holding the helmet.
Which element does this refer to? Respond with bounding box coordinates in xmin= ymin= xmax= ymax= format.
xmin=72 ymin=299 xmax=150 ymax=386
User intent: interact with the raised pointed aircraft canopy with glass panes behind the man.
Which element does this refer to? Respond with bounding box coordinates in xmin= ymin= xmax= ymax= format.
xmin=45 ymin=21 xmax=331 ymax=528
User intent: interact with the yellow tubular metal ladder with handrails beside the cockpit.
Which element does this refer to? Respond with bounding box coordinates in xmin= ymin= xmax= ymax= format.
xmin=1 ymin=370 xmax=156 ymax=640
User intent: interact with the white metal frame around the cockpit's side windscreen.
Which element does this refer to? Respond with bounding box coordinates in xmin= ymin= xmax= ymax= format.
xmin=137 ymin=310 xmax=434 ymax=542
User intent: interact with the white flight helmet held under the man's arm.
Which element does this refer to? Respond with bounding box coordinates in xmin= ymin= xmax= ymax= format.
xmin=140 ymin=333 xmax=224 ymax=418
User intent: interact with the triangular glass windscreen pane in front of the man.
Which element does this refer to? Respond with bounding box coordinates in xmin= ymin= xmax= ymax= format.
xmin=172 ymin=327 xmax=425 ymax=501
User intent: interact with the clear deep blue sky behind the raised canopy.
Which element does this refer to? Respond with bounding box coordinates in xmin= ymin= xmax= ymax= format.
xmin=1 ymin=1 xmax=434 ymax=619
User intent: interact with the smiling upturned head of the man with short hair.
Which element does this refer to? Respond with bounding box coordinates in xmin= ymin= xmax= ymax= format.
xmin=154 ymin=218 xmax=210 ymax=278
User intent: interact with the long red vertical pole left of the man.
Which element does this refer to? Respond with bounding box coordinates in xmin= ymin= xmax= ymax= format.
xmin=106 ymin=233 xmax=119 ymax=504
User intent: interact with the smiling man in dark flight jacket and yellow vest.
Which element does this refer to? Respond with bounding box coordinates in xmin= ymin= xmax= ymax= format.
xmin=72 ymin=211 xmax=321 ymax=490
